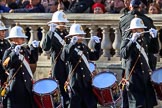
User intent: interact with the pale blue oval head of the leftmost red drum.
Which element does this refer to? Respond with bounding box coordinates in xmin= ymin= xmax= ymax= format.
xmin=33 ymin=79 xmax=57 ymax=94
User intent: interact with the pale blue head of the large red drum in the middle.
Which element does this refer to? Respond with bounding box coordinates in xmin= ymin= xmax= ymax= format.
xmin=92 ymin=72 xmax=117 ymax=88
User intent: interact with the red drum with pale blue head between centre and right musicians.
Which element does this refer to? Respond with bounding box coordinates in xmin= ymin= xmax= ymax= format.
xmin=92 ymin=72 xmax=121 ymax=106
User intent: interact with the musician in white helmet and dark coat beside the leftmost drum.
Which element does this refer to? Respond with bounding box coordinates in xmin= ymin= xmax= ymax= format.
xmin=1 ymin=26 xmax=39 ymax=108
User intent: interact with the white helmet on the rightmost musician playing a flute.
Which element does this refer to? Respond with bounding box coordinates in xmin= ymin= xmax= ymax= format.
xmin=126 ymin=17 xmax=147 ymax=31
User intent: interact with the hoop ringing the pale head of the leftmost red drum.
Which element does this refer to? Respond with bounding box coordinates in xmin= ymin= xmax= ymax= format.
xmin=32 ymin=78 xmax=58 ymax=96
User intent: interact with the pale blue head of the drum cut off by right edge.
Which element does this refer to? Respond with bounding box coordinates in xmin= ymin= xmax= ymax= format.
xmin=151 ymin=69 xmax=162 ymax=84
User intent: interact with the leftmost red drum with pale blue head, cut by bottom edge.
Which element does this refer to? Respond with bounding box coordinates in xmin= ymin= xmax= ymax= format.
xmin=33 ymin=78 xmax=61 ymax=108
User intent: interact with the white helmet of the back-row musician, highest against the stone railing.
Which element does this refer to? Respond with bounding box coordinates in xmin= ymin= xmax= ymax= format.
xmin=48 ymin=10 xmax=69 ymax=24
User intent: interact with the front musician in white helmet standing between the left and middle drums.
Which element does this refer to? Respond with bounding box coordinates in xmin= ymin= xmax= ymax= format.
xmin=61 ymin=24 xmax=100 ymax=108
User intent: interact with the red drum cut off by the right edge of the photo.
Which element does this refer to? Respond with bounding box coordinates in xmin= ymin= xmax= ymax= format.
xmin=151 ymin=68 xmax=162 ymax=100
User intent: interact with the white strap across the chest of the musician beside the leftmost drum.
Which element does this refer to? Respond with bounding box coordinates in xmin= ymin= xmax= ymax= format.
xmin=19 ymin=54 xmax=33 ymax=78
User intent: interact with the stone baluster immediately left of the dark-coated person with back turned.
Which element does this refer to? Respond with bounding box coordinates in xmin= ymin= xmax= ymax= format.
xmin=112 ymin=28 xmax=121 ymax=57
